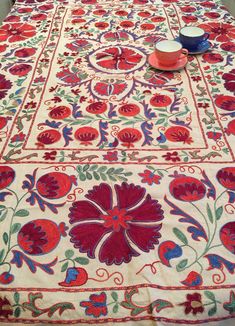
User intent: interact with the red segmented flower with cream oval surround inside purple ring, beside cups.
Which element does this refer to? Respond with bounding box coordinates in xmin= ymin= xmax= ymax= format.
xmin=89 ymin=46 xmax=146 ymax=74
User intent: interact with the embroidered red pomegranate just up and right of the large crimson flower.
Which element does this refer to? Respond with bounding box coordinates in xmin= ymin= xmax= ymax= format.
xmin=169 ymin=176 xmax=206 ymax=202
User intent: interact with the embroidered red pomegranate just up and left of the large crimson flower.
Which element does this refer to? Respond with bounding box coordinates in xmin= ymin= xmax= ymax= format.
xmin=36 ymin=172 xmax=77 ymax=199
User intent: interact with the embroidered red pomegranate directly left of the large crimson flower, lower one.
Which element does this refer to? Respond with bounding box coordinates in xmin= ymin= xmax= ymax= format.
xmin=18 ymin=219 xmax=66 ymax=255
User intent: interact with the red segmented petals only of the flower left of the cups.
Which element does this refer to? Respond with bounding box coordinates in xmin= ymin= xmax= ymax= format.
xmin=96 ymin=47 xmax=142 ymax=70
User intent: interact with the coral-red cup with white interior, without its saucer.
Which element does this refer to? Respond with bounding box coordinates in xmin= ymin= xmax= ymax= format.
xmin=155 ymin=40 xmax=188 ymax=67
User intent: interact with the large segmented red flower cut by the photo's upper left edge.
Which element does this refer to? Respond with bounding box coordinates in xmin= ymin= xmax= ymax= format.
xmin=0 ymin=23 xmax=36 ymax=43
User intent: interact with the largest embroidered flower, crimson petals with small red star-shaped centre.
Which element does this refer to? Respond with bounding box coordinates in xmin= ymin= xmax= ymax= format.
xmin=69 ymin=183 xmax=163 ymax=265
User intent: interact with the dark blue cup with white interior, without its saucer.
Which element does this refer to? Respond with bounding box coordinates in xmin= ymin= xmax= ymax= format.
xmin=179 ymin=26 xmax=210 ymax=51
